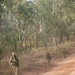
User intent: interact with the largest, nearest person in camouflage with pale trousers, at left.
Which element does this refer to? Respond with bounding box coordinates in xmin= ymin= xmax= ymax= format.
xmin=9 ymin=52 xmax=19 ymax=75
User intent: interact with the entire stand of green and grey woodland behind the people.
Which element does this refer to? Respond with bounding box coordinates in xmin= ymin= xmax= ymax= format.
xmin=0 ymin=0 xmax=75 ymax=57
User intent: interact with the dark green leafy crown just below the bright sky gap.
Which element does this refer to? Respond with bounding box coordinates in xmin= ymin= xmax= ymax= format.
xmin=18 ymin=3 xmax=35 ymax=22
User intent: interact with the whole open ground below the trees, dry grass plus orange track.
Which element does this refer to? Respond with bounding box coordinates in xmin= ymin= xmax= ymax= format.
xmin=0 ymin=42 xmax=75 ymax=75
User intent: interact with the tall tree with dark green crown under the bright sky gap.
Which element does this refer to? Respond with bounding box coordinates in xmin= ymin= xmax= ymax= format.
xmin=18 ymin=1 xmax=37 ymax=48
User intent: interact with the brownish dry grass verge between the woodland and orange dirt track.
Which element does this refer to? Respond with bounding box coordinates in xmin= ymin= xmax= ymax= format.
xmin=0 ymin=42 xmax=75 ymax=75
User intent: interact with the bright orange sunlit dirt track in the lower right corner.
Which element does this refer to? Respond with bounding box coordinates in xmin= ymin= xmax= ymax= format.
xmin=43 ymin=57 xmax=75 ymax=75
